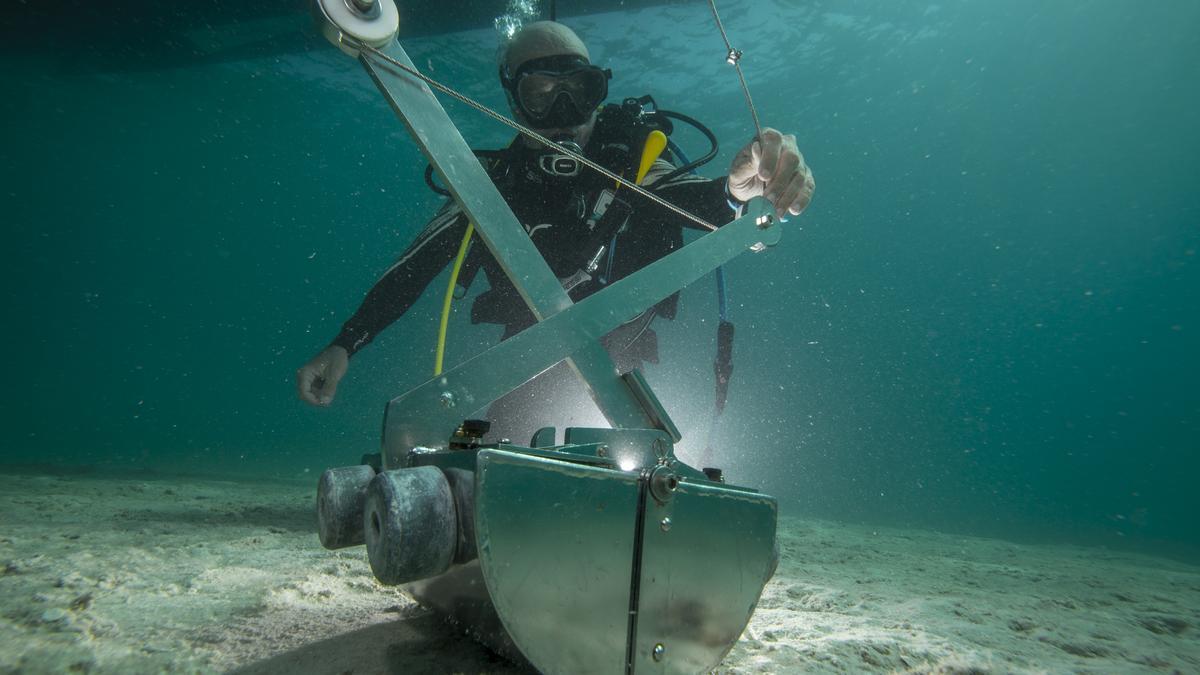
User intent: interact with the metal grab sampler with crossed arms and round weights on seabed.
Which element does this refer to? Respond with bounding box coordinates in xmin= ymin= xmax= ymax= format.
xmin=307 ymin=0 xmax=780 ymax=674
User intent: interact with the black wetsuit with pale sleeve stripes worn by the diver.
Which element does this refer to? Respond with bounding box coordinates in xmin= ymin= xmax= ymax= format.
xmin=332 ymin=118 xmax=733 ymax=442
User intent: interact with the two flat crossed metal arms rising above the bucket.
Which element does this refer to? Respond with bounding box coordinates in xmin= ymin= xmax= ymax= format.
xmin=359 ymin=42 xmax=780 ymax=466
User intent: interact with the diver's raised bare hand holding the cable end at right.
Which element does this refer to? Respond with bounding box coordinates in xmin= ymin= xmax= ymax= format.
xmin=730 ymin=127 xmax=817 ymax=219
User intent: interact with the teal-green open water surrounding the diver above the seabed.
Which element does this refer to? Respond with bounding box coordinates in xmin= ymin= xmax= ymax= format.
xmin=0 ymin=0 xmax=1200 ymax=555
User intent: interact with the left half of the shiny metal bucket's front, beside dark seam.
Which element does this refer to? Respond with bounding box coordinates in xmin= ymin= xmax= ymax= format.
xmin=475 ymin=450 xmax=637 ymax=675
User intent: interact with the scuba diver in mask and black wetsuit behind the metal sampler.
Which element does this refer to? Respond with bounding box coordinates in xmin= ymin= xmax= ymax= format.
xmin=296 ymin=22 xmax=815 ymax=443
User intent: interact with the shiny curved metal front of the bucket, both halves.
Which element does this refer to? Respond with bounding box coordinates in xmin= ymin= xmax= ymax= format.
xmin=475 ymin=449 xmax=778 ymax=674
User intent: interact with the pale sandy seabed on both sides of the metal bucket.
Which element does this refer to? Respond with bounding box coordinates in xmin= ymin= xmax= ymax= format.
xmin=0 ymin=473 xmax=1200 ymax=674
